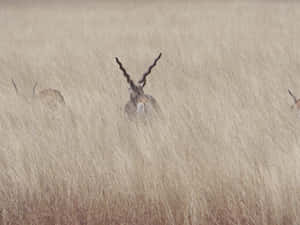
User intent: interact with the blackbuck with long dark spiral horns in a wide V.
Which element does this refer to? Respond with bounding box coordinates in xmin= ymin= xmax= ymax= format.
xmin=115 ymin=53 xmax=161 ymax=119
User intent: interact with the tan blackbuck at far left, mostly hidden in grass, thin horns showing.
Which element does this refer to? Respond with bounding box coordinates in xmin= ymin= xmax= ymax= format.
xmin=12 ymin=79 xmax=65 ymax=110
